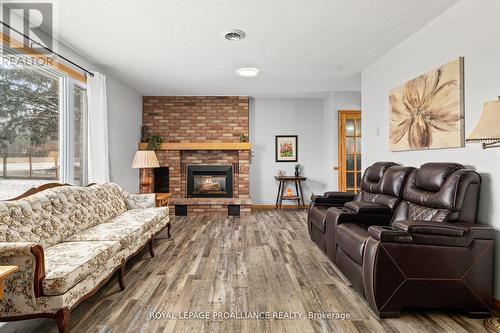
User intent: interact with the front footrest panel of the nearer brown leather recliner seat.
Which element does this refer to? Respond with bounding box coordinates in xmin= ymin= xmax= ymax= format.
xmin=337 ymin=223 xmax=370 ymax=265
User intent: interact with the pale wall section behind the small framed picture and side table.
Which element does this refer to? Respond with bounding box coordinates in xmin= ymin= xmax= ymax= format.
xmin=250 ymin=98 xmax=325 ymax=204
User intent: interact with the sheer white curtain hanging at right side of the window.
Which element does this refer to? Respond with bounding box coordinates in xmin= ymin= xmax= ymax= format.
xmin=87 ymin=72 xmax=109 ymax=183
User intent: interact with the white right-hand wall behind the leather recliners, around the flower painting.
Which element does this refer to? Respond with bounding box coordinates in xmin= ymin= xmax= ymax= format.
xmin=362 ymin=0 xmax=500 ymax=299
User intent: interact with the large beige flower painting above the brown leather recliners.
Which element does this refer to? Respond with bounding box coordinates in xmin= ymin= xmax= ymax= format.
xmin=389 ymin=58 xmax=464 ymax=151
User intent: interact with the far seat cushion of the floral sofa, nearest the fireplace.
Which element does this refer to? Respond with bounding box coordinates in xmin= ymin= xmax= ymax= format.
xmin=66 ymin=207 xmax=168 ymax=249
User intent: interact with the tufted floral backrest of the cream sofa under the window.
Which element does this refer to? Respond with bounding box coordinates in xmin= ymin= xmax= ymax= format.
xmin=0 ymin=184 xmax=127 ymax=248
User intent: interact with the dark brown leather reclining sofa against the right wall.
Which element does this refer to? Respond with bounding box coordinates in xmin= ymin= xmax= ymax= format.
xmin=308 ymin=163 xmax=494 ymax=317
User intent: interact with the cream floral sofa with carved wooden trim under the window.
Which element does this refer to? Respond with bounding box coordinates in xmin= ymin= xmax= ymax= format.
xmin=0 ymin=183 xmax=170 ymax=332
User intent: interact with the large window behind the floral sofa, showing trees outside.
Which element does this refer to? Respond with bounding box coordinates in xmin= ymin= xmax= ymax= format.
xmin=0 ymin=51 xmax=87 ymax=200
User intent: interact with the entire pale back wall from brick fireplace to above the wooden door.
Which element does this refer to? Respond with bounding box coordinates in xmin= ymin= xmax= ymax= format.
xmin=250 ymin=91 xmax=361 ymax=204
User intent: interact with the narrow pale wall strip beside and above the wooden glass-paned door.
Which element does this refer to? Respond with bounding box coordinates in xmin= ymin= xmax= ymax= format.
xmin=323 ymin=91 xmax=361 ymax=191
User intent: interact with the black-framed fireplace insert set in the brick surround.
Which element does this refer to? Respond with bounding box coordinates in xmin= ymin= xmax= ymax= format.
xmin=187 ymin=165 xmax=233 ymax=198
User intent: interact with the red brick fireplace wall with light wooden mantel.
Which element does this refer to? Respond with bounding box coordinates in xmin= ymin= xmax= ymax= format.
xmin=141 ymin=96 xmax=251 ymax=215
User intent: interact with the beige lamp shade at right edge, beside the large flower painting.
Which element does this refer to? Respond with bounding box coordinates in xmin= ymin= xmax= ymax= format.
xmin=467 ymin=98 xmax=500 ymax=143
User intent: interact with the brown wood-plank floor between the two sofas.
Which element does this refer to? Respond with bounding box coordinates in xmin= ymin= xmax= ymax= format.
xmin=0 ymin=210 xmax=490 ymax=333
